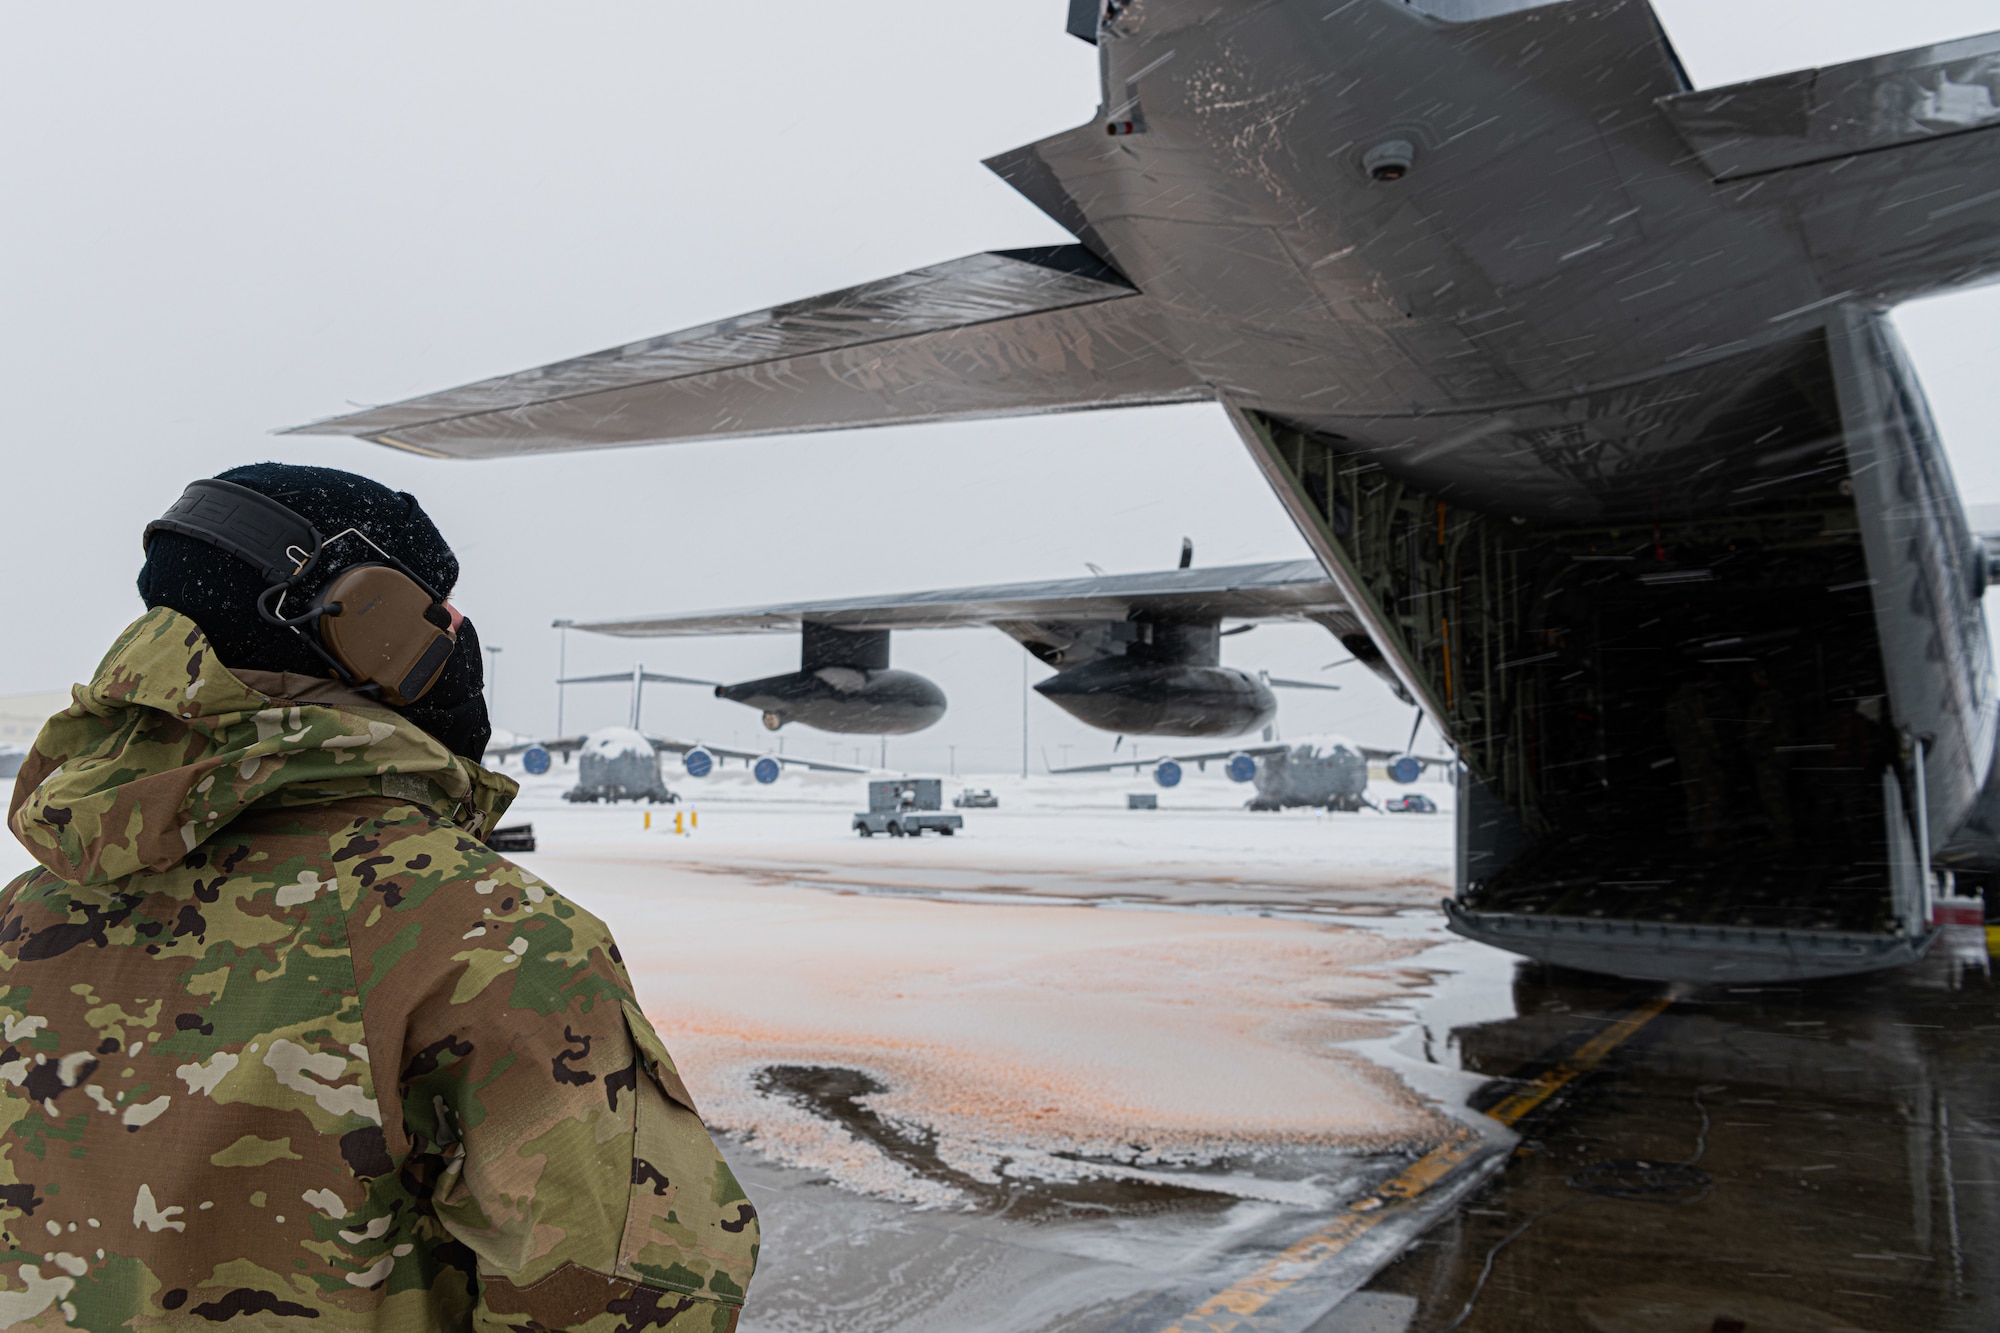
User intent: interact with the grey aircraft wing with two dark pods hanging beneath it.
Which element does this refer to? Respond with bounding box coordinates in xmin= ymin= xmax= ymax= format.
xmin=548 ymin=542 xmax=1360 ymax=737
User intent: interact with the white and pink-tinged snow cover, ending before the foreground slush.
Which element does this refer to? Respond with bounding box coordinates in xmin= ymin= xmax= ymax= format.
xmin=510 ymin=765 xmax=1454 ymax=1205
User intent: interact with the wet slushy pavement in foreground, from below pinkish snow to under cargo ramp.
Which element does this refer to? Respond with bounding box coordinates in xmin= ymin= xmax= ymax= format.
xmin=716 ymin=908 xmax=2000 ymax=1333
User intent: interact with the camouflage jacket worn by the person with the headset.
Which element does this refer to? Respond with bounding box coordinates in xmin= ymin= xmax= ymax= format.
xmin=0 ymin=610 xmax=758 ymax=1333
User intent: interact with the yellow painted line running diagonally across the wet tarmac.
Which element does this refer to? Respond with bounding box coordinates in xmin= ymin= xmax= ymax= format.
xmin=1162 ymin=995 xmax=1674 ymax=1333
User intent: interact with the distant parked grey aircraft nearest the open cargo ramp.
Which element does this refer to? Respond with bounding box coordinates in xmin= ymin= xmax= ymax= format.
xmin=1050 ymin=719 xmax=1458 ymax=813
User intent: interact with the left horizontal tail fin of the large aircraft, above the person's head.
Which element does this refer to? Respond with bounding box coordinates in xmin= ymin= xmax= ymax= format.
xmin=286 ymin=244 xmax=1214 ymax=458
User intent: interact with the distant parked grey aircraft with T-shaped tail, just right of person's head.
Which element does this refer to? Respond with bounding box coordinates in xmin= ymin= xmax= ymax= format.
xmin=488 ymin=664 xmax=868 ymax=803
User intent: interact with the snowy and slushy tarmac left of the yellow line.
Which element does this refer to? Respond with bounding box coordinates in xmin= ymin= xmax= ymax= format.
xmin=496 ymin=765 xmax=1512 ymax=1329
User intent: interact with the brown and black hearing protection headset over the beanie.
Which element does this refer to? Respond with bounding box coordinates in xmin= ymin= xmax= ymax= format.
xmin=144 ymin=480 xmax=460 ymax=709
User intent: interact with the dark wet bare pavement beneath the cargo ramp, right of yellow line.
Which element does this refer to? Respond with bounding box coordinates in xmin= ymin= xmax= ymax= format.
xmin=1352 ymin=933 xmax=2000 ymax=1333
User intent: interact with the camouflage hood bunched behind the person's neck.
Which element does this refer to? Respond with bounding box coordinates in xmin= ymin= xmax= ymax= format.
xmin=8 ymin=606 xmax=520 ymax=885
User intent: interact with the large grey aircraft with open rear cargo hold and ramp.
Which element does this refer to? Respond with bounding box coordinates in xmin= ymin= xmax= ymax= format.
xmin=292 ymin=0 xmax=2000 ymax=981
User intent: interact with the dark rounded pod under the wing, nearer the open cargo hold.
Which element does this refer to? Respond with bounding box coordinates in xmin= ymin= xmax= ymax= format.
xmin=1034 ymin=656 xmax=1278 ymax=737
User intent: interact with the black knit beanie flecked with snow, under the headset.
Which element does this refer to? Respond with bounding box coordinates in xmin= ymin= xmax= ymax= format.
xmin=138 ymin=462 xmax=492 ymax=763
